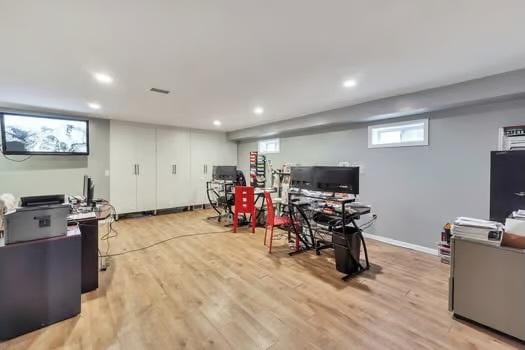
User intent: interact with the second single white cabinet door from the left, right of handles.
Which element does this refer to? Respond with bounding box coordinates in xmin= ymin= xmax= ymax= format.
xmin=135 ymin=127 xmax=157 ymax=211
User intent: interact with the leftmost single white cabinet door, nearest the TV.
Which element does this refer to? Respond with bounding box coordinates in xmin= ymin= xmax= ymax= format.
xmin=109 ymin=121 xmax=137 ymax=214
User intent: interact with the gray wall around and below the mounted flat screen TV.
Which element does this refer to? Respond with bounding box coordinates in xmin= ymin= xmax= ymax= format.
xmin=0 ymin=119 xmax=109 ymax=198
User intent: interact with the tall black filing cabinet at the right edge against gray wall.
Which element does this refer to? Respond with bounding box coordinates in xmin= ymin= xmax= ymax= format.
xmin=490 ymin=151 xmax=525 ymax=222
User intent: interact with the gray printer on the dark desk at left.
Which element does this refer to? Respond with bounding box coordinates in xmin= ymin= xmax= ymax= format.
xmin=4 ymin=203 xmax=70 ymax=245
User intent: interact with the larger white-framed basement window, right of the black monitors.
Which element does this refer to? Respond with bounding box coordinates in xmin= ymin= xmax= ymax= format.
xmin=368 ymin=118 xmax=428 ymax=148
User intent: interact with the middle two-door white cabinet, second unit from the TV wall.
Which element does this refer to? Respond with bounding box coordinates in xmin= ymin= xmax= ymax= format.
xmin=157 ymin=128 xmax=192 ymax=209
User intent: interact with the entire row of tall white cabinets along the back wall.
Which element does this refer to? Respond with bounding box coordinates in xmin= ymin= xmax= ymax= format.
xmin=110 ymin=121 xmax=237 ymax=214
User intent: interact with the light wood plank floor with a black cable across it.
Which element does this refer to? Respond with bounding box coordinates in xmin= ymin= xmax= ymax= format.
xmin=0 ymin=211 xmax=524 ymax=350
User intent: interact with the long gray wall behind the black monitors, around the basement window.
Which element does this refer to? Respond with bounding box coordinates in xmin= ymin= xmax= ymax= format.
xmin=238 ymin=99 xmax=525 ymax=248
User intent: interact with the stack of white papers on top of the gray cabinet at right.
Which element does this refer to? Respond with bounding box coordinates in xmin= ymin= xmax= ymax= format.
xmin=452 ymin=217 xmax=504 ymax=245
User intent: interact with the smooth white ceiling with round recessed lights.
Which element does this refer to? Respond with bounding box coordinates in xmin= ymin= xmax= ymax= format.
xmin=0 ymin=0 xmax=525 ymax=130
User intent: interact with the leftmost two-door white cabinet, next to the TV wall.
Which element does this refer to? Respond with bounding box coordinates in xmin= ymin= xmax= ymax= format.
xmin=110 ymin=121 xmax=157 ymax=214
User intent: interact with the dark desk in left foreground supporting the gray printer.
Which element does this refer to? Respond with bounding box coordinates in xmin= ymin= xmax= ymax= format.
xmin=0 ymin=234 xmax=81 ymax=340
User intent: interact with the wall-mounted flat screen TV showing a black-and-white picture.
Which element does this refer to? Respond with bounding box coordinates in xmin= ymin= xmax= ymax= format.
xmin=0 ymin=113 xmax=89 ymax=155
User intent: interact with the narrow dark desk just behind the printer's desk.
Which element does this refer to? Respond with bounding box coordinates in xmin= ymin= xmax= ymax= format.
xmin=68 ymin=204 xmax=112 ymax=293
